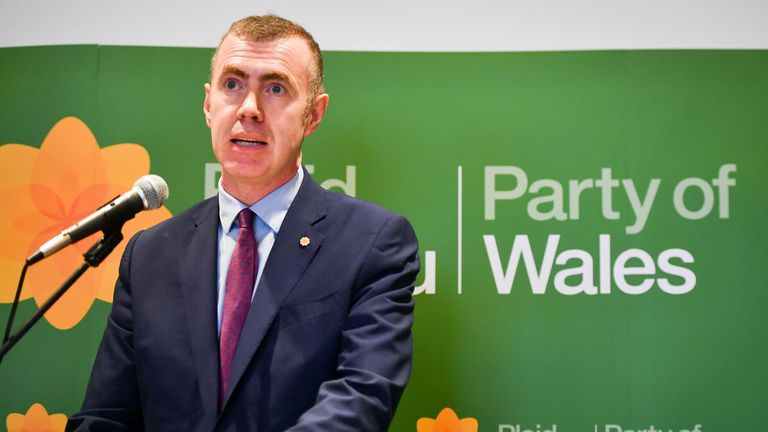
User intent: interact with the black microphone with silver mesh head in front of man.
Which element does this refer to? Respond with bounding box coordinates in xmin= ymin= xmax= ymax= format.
xmin=27 ymin=174 xmax=168 ymax=265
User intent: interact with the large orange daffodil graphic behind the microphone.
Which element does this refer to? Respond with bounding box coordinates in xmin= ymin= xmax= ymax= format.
xmin=0 ymin=117 xmax=171 ymax=330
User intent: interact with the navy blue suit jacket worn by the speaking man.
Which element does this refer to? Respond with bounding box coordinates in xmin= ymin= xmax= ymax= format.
xmin=68 ymin=175 xmax=419 ymax=432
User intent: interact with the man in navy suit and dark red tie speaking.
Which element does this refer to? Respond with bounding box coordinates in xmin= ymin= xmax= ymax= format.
xmin=68 ymin=16 xmax=419 ymax=432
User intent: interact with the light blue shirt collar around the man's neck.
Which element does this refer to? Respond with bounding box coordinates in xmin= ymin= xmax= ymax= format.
xmin=219 ymin=167 xmax=304 ymax=233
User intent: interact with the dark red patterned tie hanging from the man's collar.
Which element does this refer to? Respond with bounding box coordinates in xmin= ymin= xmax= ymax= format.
xmin=219 ymin=208 xmax=259 ymax=406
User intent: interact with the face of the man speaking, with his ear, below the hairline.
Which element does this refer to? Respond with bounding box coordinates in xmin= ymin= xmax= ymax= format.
xmin=204 ymin=34 xmax=328 ymax=204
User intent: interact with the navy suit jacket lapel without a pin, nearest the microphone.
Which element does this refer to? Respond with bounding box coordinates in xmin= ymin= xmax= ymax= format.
xmin=179 ymin=198 xmax=219 ymax=419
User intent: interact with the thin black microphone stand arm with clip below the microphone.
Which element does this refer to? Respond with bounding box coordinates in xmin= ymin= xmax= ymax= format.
xmin=0 ymin=230 xmax=123 ymax=361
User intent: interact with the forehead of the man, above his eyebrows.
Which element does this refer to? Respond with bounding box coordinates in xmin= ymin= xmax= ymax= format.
xmin=214 ymin=34 xmax=311 ymax=83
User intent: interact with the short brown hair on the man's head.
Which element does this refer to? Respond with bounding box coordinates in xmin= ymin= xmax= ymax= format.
xmin=208 ymin=14 xmax=325 ymax=98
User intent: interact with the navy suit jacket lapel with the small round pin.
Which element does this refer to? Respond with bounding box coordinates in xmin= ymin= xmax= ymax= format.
xmin=225 ymin=172 xmax=325 ymax=406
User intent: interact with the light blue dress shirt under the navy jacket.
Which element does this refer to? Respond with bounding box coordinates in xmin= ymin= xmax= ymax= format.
xmin=216 ymin=167 xmax=304 ymax=336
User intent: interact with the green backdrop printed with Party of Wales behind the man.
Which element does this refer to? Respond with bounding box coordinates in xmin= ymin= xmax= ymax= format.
xmin=0 ymin=46 xmax=768 ymax=432
